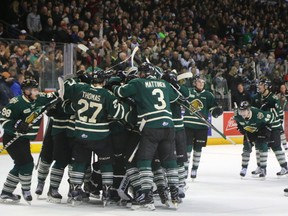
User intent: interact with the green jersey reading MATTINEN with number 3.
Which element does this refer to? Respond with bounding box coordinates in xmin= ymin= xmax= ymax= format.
xmin=113 ymin=78 xmax=179 ymax=128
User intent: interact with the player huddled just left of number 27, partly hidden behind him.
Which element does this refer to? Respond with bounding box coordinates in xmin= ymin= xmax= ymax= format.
xmin=35 ymin=70 xmax=90 ymax=203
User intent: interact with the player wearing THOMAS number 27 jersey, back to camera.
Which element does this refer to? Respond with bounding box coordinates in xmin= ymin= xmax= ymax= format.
xmin=64 ymin=71 xmax=127 ymax=205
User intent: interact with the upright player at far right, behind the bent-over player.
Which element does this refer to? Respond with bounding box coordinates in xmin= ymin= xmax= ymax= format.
xmin=252 ymin=78 xmax=288 ymax=176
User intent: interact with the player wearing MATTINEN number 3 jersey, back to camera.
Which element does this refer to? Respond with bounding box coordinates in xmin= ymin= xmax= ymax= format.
xmin=113 ymin=62 xmax=179 ymax=209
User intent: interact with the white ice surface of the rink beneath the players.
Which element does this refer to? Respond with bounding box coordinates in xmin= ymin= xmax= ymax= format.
xmin=0 ymin=145 xmax=288 ymax=216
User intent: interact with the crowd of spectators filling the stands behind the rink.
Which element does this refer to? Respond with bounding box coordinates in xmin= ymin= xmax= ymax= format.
xmin=0 ymin=0 xmax=288 ymax=110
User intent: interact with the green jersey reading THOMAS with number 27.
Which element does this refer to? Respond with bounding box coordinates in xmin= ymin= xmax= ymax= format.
xmin=64 ymin=83 xmax=127 ymax=140
